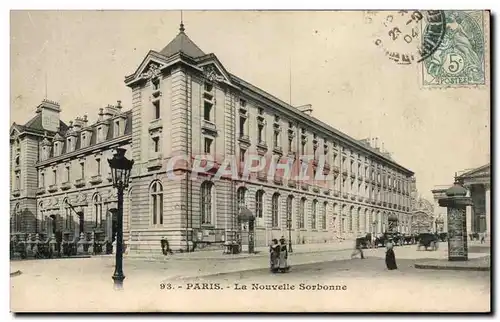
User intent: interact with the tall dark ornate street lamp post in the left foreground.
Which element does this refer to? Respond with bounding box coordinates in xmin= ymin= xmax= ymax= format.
xmin=108 ymin=148 xmax=134 ymax=289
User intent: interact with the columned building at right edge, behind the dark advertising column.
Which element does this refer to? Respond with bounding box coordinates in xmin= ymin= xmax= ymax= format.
xmin=432 ymin=163 xmax=491 ymax=236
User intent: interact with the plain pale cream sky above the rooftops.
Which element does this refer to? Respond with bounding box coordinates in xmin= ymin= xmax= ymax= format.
xmin=9 ymin=11 xmax=490 ymax=199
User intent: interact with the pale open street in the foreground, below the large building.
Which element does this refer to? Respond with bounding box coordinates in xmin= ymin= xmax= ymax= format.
xmin=11 ymin=245 xmax=490 ymax=311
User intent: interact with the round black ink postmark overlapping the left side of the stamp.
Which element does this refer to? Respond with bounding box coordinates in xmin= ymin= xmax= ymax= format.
xmin=370 ymin=10 xmax=446 ymax=65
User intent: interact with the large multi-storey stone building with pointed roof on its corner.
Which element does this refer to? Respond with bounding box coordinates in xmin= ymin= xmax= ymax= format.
xmin=11 ymin=24 xmax=414 ymax=252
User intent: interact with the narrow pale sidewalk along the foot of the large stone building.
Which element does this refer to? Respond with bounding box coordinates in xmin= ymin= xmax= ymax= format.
xmin=126 ymin=240 xmax=354 ymax=261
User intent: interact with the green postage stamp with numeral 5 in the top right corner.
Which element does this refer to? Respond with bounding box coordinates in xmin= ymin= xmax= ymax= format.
xmin=421 ymin=10 xmax=487 ymax=87
